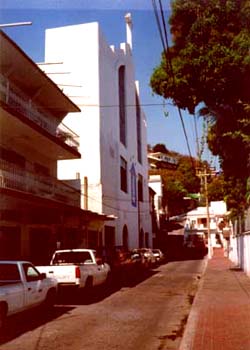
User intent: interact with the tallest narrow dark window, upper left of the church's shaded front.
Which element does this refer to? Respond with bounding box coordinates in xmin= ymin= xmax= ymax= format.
xmin=118 ymin=66 xmax=126 ymax=146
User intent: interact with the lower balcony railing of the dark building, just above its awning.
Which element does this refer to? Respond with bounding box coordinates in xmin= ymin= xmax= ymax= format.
xmin=0 ymin=159 xmax=80 ymax=207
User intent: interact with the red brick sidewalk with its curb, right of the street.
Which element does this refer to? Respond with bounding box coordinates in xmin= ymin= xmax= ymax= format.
xmin=180 ymin=249 xmax=250 ymax=350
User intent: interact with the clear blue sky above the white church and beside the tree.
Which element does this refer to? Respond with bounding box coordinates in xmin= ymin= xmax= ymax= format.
xmin=0 ymin=0 xmax=218 ymax=167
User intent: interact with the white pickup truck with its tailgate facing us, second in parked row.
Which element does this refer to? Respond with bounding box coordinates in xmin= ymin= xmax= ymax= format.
xmin=37 ymin=249 xmax=110 ymax=290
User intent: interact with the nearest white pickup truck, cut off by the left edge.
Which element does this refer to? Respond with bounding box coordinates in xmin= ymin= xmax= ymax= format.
xmin=0 ymin=260 xmax=57 ymax=328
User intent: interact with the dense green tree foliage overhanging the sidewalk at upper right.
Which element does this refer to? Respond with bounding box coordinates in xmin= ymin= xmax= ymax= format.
xmin=150 ymin=0 xmax=250 ymax=210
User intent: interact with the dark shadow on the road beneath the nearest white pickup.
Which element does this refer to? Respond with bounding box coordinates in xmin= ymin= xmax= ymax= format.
xmin=0 ymin=306 xmax=73 ymax=350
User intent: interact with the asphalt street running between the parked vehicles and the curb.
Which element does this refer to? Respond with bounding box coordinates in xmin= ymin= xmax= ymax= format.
xmin=0 ymin=260 xmax=205 ymax=350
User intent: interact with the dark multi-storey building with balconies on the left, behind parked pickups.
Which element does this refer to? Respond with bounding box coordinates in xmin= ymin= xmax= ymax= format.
xmin=0 ymin=31 xmax=111 ymax=263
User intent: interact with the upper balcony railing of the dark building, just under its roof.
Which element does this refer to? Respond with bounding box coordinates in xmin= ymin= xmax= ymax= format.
xmin=0 ymin=74 xmax=79 ymax=149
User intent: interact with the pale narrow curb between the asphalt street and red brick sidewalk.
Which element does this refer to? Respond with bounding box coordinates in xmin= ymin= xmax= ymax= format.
xmin=179 ymin=258 xmax=209 ymax=350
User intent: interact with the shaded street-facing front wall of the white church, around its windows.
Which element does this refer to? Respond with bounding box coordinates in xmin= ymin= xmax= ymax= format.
xmin=99 ymin=26 xmax=152 ymax=247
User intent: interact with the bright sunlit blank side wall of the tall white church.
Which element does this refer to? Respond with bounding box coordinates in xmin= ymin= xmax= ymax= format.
xmin=45 ymin=22 xmax=102 ymax=212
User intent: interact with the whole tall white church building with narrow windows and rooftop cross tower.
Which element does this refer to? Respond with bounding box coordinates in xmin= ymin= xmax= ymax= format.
xmin=39 ymin=14 xmax=152 ymax=249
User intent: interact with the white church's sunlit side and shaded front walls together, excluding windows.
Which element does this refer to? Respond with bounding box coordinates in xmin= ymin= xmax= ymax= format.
xmin=45 ymin=23 xmax=152 ymax=248
